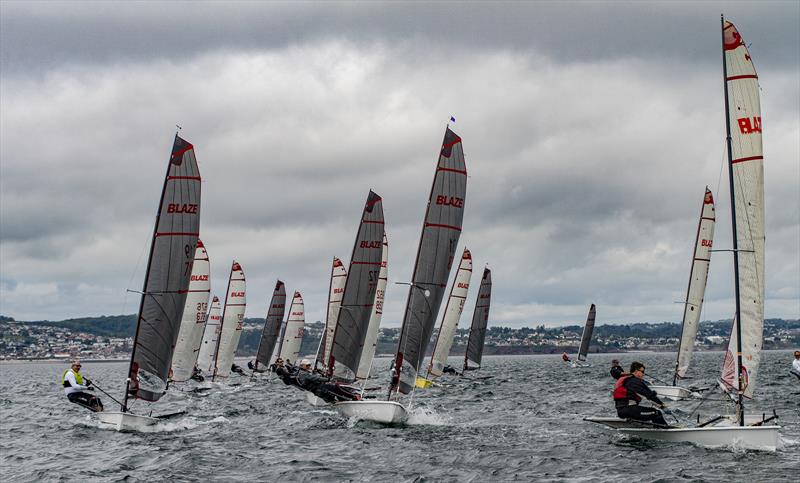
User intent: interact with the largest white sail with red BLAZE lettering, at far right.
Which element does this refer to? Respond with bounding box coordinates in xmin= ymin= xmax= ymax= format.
xmin=723 ymin=22 xmax=765 ymax=398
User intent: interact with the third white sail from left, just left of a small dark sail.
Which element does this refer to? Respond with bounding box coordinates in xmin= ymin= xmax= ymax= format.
xmin=214 ymin=261 xmax=247 ymax=380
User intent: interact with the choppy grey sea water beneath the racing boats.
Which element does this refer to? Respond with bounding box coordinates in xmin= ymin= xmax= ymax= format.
xmin=0 ymin=351 xmax=800 ymax=482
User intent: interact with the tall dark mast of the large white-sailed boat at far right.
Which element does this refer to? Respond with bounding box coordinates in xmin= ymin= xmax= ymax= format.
xmin=720 ymin=15 xmax=744 ymax=426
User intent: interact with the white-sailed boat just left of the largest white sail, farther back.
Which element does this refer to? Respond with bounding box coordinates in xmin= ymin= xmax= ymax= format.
xmin=650 ymin=187 xmax=716 ymax=401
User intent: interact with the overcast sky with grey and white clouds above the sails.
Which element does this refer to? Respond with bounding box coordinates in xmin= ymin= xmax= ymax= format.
xmin=0 ymin=0 xmax=800 ymax=327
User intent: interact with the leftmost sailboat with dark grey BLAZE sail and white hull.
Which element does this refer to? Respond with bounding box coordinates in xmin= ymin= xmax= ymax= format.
xmin=95 ymin=134 xmax=200 ymax=431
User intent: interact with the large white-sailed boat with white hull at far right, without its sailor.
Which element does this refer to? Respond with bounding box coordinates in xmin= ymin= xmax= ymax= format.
xmin=586 ymin=17 xmax=780 ymax=451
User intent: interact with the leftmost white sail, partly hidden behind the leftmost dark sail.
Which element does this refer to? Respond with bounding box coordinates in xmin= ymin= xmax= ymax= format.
xmin=172 ymin=239 xmax=211 ymax=382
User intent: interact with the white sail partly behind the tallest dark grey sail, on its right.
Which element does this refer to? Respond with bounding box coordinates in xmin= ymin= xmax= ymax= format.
xmin=428 ymin=248 xmax=472 ymax=377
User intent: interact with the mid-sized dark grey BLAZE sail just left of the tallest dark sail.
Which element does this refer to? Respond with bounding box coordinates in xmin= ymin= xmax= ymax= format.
xmin=327 ymin=191 xmax=384 ymax=381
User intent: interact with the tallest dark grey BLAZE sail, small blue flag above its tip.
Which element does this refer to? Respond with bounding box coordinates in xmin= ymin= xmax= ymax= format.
xmin=390 ymin=127 xmax=467 ymax=394
